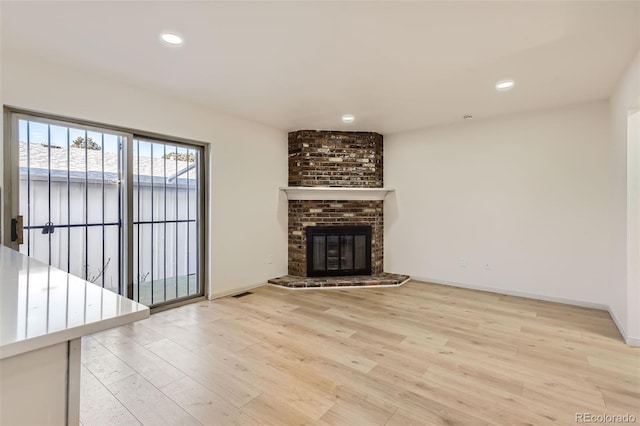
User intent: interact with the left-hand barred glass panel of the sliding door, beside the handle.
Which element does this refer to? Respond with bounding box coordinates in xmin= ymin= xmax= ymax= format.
xmin=17 ymin=118 xmax=125 ymax=293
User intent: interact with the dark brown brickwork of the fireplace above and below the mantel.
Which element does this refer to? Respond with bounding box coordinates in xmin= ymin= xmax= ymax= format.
xmin=288 ymin=130 xmax=384 ymax=277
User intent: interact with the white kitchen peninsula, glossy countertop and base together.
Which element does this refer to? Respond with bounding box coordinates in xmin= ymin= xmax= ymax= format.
xmin=0 ymin=246 xmax=149 ymax=426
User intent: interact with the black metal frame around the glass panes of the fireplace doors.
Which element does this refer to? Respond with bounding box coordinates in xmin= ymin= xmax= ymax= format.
xmin=306 ymin=226 xmax=371 ymax=277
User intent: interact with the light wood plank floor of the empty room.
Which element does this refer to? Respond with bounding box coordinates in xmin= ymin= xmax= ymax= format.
xmin=81 ymin=282 xmax=640 ymax=426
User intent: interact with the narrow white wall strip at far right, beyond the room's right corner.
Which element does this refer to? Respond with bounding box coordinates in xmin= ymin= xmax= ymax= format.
xmin=609 ymin=53 xmax=640 ymax=346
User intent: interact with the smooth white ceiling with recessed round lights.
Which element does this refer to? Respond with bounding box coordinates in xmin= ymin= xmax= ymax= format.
xmin=0 ymin=0 xmax=640 ymax=133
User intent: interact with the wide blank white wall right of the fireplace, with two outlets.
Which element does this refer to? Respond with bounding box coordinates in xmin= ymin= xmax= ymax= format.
xmin=385 ymin=101 xmax=612 ymax=308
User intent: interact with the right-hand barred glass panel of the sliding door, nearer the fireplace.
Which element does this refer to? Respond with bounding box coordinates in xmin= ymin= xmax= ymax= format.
xmin=133 ymin=139 xmax=203 ymax=306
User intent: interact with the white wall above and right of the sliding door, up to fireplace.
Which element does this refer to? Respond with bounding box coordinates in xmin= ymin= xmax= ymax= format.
xmin=0 ymin=50 xmax=287 ymax=296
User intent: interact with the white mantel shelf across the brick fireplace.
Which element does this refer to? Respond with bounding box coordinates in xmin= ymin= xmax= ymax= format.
xmin=280 ymin=186 xmax=395 ymax=201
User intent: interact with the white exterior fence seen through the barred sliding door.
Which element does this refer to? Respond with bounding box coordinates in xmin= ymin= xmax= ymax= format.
xmin=19 ymin=173 xmax=198 ymax=296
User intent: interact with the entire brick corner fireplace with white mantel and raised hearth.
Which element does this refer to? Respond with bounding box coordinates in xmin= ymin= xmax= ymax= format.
xmin=269 ymin=130 xmax=408 ymax=287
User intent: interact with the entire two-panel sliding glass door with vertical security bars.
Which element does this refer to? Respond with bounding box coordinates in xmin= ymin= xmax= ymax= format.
xmin=3 ymin=113 xmax=204 ymax=306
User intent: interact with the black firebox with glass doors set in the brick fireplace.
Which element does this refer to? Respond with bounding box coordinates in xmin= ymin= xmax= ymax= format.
xmin=307 ymin=226 xmax=371 ymax=277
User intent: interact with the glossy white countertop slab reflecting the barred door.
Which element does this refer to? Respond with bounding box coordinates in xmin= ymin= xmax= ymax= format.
xmin=0 ymin=246 xmax=149 ymax=359
